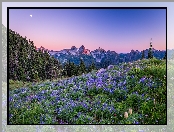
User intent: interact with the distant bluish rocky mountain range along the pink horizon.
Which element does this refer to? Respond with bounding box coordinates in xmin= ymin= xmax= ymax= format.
xmin=46 ymin=45 xmax=166 ymax=68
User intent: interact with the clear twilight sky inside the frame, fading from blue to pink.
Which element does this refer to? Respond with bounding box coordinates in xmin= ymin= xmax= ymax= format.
xmin=4 ymin=2 xmax=170 ymax=53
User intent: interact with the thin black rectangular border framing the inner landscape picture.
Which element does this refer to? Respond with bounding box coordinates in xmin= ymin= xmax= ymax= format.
xmin=7 ymin=7 xmax=167 ymax=125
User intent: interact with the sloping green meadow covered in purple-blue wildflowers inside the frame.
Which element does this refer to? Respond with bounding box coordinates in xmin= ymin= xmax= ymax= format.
xmin=9 ymin=58 xmax=167 ymax=124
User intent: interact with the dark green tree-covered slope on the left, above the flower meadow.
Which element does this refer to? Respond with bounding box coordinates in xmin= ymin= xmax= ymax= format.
xmin=8 ymin=29 xmax=95 ymax=82
